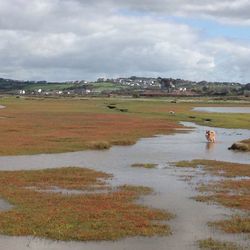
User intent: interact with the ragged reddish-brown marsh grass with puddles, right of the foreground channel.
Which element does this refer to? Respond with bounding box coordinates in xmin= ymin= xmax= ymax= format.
xmin=176 ymin=160 xmax=250 ymax=233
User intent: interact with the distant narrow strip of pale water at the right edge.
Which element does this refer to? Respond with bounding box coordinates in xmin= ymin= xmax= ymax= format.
xmin=193 ymin=107 xmax=250 ymax=114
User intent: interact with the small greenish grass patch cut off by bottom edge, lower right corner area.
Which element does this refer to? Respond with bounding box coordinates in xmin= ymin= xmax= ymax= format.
xmin=198 ymin=238 xmax=242 ymax=250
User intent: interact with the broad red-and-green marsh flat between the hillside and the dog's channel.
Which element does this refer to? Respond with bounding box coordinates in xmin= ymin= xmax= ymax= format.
xmin=0 ymin=96 xmax=250 ymax=155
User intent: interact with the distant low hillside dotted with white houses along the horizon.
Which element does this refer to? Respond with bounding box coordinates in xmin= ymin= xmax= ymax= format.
xmin=0 ymin=76 xmax=250 ymax=97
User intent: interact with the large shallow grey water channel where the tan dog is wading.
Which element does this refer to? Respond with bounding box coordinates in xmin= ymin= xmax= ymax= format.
xmin=0 ymin=123 xmax=250 ymax=250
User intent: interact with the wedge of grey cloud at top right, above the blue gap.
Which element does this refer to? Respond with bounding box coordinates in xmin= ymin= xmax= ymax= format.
xmin=82 ymin=0 xmax=250 ymax=25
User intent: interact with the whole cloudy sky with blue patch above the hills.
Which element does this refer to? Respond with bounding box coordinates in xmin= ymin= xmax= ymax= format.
xmin=0 ymin=0 xmax=250 ymax=83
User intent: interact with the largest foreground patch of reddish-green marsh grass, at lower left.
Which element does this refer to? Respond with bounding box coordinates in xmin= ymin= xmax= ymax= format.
xmin=0 ymin=167 xmax=172 ymax=241
